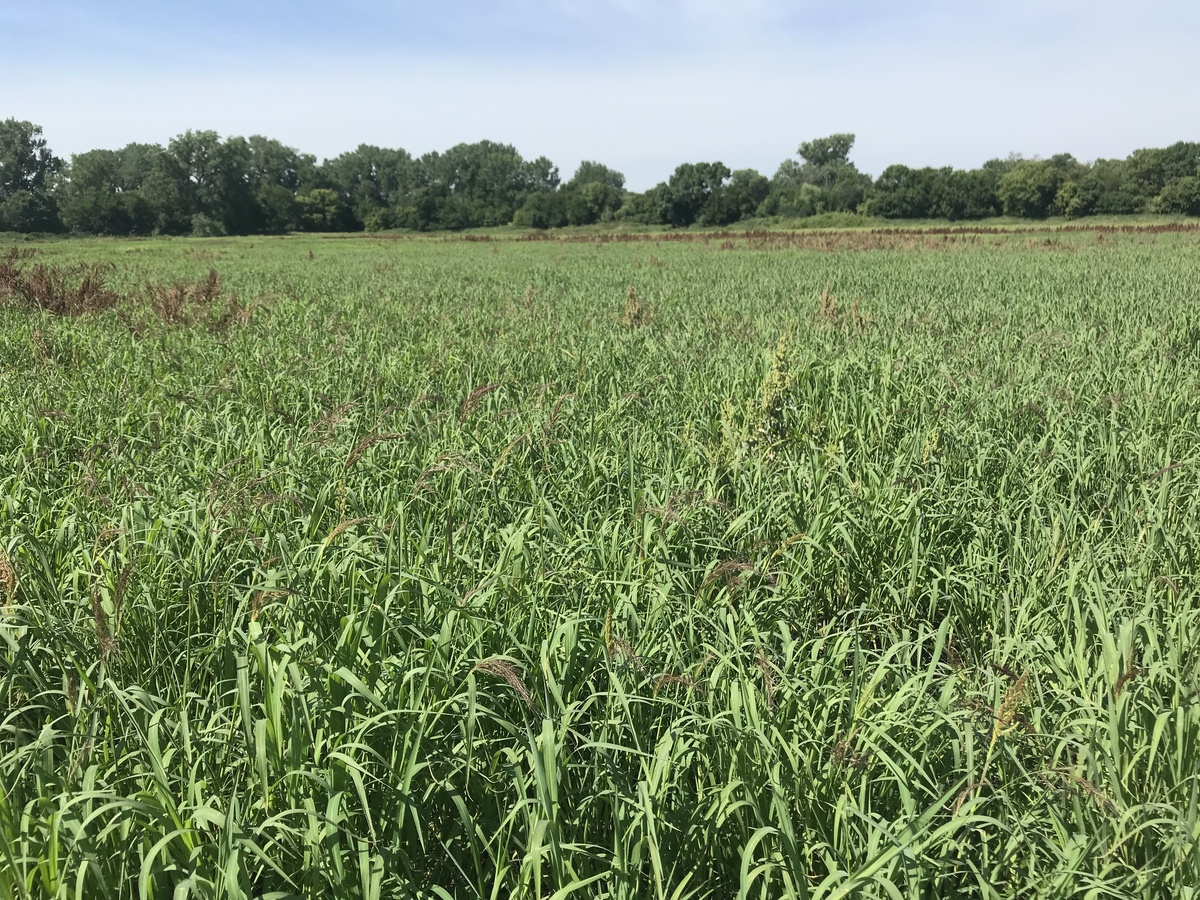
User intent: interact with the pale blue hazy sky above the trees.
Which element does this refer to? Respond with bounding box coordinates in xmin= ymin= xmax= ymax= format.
xmin=0 ymin=0 xmax=1200 ymax=190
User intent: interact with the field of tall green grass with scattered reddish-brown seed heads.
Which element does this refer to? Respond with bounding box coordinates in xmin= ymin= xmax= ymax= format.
xmin=0 ymin=232 xmax=1200 ymax=900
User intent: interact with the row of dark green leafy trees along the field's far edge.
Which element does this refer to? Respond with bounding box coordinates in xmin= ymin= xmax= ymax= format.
xmin=7 ymin=119 xmax=1200 ymax=236
